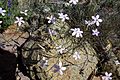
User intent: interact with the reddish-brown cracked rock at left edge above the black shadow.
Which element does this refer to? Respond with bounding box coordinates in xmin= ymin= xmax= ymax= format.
xmin=0 ymin=24 xmax=29 ymax=53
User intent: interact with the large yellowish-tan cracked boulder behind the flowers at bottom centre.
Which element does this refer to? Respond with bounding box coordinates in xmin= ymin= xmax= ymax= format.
xmin=22 ymin=21 xmax=98 ymax=80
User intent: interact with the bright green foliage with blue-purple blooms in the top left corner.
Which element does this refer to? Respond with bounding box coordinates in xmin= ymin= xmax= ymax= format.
xmin=0 ymin=0 xmax=31 ymax=32
